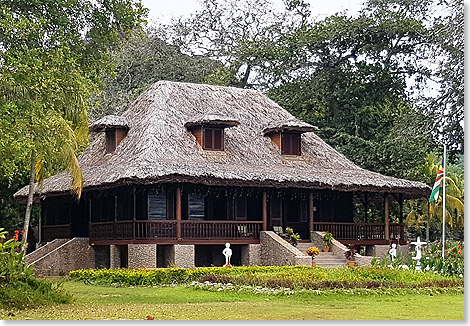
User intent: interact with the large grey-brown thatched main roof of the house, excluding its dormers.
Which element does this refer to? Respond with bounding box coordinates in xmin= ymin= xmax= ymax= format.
xmin=15 ymin=81 xmax=430 ymax=198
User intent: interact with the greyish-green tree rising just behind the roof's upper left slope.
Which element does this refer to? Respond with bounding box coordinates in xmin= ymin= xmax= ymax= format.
xmin=92 ymin=28 xmax=222 ymax=121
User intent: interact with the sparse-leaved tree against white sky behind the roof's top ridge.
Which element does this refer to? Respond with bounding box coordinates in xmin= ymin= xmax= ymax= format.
xmin=161 ymin=0 xmax=310 ymax=88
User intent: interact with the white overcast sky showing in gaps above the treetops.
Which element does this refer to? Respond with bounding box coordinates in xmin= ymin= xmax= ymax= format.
xmin=142 ymin=0 xmax=364 ymax=23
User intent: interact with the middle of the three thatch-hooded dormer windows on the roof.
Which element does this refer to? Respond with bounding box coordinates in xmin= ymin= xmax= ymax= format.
xmin=185 ymin=115 xmax=239 ymax=151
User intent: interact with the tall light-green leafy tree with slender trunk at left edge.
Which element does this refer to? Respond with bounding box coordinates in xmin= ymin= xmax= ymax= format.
xmin=0 ymin=0 xmax=146 ymax=250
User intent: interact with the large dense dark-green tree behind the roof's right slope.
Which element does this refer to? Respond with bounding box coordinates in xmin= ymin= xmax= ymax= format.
xmin=263 ymin=0 xmax=435 ymax=178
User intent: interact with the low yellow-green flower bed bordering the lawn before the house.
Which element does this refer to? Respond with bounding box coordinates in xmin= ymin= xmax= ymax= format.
xmin=69 ymin=266 xmax=463 ymax=289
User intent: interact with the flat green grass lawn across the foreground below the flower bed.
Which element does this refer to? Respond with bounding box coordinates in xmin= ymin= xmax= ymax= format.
xmin=0 ymin=281 xmax=464 ymax=320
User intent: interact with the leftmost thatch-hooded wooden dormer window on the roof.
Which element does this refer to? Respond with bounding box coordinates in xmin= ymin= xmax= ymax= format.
xmin=90 ymin=115 xmax=129 ymax=154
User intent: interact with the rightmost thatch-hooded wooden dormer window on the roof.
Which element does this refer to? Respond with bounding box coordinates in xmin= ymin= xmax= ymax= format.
xmin=263 ymin=119 xmax=317 ymax=156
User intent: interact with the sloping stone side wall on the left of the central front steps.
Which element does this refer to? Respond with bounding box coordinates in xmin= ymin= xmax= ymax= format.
xmin=260 ymin=231 xmax=312 ymax=266
